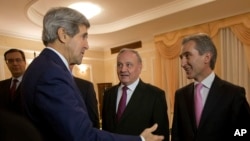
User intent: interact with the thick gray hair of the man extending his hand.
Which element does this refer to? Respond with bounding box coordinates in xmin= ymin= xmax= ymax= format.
xmin=42 ymin=7 xmax=90 ymax=46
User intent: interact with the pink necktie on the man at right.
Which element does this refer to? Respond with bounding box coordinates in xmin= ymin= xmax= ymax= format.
xmin=194 ymin=83 xmax=203 ymax=127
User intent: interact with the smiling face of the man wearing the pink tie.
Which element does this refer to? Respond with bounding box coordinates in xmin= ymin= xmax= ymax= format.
xmin=180 ymin=40 xmax=212 ymax=82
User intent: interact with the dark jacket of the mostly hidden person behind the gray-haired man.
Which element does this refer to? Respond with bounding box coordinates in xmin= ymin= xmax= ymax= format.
xmin=74 ymin=77 xmax=100 ymax=129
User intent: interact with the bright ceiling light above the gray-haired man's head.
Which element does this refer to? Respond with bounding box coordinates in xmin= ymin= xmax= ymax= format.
xmin=68 ymin=2 xmax=101 ymax=19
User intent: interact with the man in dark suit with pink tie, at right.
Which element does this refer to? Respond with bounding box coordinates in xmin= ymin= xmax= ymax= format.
xmin=172 ymin=33 xmax=250 ymax=141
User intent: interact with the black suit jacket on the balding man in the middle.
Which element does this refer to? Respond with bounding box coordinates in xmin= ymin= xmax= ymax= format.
xmin=102 ymin=80 xmax=169 ymax=141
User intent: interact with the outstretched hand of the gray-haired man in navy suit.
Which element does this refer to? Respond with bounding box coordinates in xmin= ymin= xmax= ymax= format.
xmin=141 ymin=124 xmax=164 ymax=141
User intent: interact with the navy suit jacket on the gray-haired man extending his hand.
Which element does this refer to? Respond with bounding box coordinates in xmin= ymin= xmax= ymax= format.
xmin=21 ymin=48 xmax=140 ymax=141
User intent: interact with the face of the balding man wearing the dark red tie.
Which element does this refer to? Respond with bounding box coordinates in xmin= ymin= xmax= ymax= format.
xmin=117 ymin=51 xmax=142 ymax=85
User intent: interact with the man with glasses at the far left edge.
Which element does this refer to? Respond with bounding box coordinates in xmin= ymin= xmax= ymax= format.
xmin=0 ymin=49 xmax=26 ymax=114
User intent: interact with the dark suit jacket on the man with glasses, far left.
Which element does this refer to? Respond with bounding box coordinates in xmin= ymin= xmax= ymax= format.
xmin=0 ymin=78 xmax=22 ymax=115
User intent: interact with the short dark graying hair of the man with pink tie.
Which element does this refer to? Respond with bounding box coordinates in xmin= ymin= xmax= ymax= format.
xmin=182 ymin=33 xmax=217 ymax=70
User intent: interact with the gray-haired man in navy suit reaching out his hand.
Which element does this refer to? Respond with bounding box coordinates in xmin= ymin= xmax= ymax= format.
xmin=21 ymin=7 xmax=164 ymax=141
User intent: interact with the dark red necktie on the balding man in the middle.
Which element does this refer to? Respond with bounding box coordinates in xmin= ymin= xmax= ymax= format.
xmin=116 ymin=86 xmax=128 ymax=121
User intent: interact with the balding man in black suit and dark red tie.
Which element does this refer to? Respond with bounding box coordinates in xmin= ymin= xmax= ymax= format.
xmin=102 ymin=49 xmax=169 ymax=141
